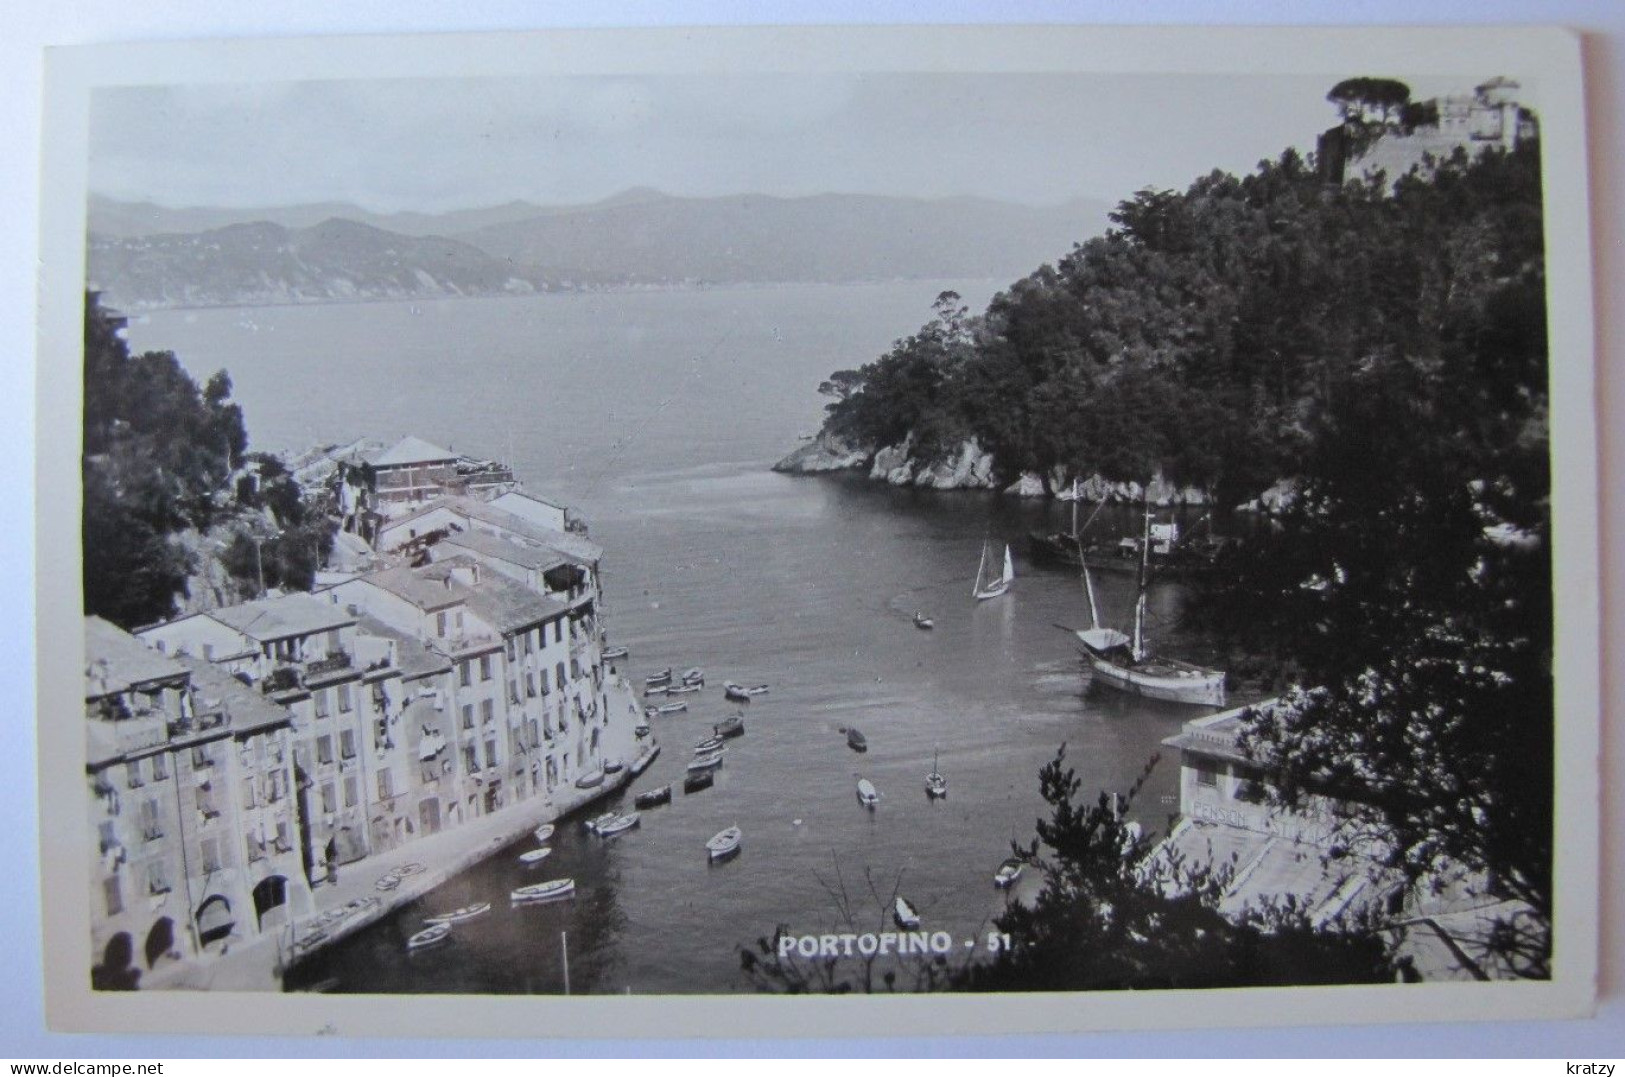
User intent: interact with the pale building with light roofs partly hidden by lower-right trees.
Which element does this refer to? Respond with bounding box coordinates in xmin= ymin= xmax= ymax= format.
xmin=1151 ymin=700 xmax=1528 ymax=980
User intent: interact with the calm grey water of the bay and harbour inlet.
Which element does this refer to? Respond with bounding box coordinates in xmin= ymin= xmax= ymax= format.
xmin=128 ymin=281 xmax=1204 ymax=993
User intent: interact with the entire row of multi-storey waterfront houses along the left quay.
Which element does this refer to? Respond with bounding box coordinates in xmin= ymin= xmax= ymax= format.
xmin=85 ymin=448 xmax=640 ymax=986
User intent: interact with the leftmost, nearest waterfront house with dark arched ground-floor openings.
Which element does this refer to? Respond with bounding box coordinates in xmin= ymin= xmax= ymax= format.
xmin=85 ymin=617 xmax=310 ymax=988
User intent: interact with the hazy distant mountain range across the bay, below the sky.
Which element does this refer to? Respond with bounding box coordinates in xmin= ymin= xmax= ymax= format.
xmin=89 ymin=188 xmax=1108 ymax=310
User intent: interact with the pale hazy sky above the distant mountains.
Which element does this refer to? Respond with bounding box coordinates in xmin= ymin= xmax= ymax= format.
xmin=89 ymin=71 xmax=1497 ymax=213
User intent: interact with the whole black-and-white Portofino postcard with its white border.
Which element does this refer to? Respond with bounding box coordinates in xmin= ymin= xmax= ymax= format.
xmin=39 ymin=28 xmax=1597 ymax=1035
